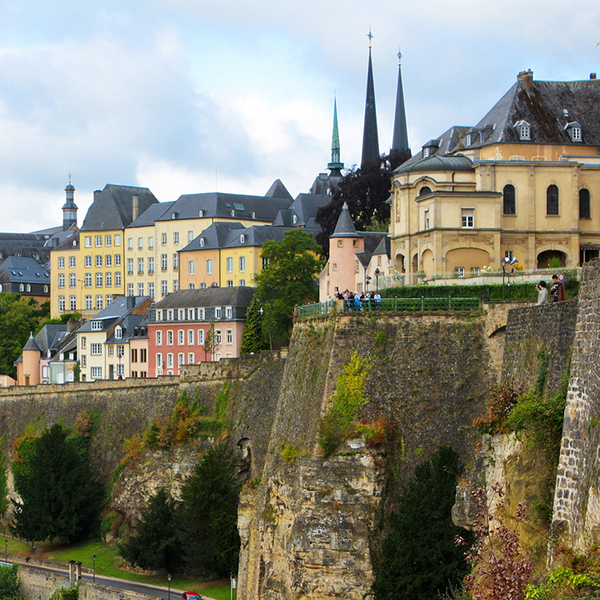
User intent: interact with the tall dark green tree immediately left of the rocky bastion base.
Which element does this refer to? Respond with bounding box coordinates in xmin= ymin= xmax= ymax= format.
xmin=179 ymin=444 xmax=241 ymax=576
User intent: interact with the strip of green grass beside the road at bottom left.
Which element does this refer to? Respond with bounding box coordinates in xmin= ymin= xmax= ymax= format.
xmin=7 ymin=538 xmax=235 ymax=600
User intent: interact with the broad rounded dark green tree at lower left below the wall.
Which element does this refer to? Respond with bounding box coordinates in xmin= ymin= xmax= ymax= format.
xmin=11 ymin=424 xmax=104 ymax=543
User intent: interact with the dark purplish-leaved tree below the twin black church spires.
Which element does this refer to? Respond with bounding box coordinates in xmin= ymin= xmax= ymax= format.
xmin=316 ymin=151 xmax=410 ymax=256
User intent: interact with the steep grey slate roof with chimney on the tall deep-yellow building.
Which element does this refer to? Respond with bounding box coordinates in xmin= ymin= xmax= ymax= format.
xmin=81 ymin=184 xmax=158 ymax=231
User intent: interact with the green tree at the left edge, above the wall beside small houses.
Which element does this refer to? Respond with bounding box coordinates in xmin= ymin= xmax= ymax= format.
xmin=0 ymin=292 xmax=40 ymax=377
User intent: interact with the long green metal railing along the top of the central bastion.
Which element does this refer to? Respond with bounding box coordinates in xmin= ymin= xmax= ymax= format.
xmin=297 ymin=298 xmax=480 ymax=318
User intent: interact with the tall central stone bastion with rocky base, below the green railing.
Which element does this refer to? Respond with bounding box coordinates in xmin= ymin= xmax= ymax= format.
xmin=238 ymin=314 xmax=495 ymax=600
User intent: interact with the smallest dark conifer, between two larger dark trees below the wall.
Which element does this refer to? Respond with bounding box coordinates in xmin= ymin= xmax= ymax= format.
xmin=119 ymin=488 xmax=182 ymax=572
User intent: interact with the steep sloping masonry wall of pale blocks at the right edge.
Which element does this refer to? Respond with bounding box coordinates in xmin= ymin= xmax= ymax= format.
xmin=552 ymin=260 xmax=600 ymax=549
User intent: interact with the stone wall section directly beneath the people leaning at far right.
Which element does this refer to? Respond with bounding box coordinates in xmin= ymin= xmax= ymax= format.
xmin=502 ymin=300 xmax=578 ymax=394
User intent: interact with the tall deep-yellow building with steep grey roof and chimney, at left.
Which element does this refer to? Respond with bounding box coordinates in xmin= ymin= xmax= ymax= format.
xmin=78 ymin=184 xmax=158 ymax=317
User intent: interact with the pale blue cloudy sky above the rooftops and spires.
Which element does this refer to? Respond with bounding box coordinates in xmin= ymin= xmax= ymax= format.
xmin=0 ymin=0 xmax=600 ymax=232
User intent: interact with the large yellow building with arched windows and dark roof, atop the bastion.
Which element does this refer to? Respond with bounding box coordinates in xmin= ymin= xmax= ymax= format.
xmin=390 ymin=71 xmax=600 ymax=282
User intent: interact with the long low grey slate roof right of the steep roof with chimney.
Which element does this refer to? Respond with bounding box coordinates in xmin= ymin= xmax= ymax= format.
xmin=157 ymin=192 xmax=292 ymax=223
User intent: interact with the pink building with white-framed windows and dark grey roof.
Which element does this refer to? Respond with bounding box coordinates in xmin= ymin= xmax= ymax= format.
xmin=148 ymin=287 xmax=255 ymax=377
